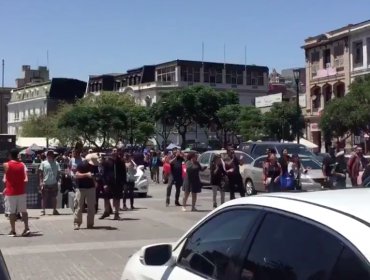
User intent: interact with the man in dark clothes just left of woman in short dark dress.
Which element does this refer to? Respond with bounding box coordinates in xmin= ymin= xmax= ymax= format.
xmin=166 ymin=150 xmax=184 ymax=207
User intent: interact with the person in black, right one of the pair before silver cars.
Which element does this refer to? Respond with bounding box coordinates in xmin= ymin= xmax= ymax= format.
xmin=226 ymin=148 xmax=245 ymax=200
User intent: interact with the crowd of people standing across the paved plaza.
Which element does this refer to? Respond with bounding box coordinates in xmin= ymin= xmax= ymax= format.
xmin=3 ymin=142 xmax=370 ymax=236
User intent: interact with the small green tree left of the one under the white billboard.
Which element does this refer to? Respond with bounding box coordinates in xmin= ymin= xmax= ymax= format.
xmin=239 ymin=106 xmax=264 ymax=140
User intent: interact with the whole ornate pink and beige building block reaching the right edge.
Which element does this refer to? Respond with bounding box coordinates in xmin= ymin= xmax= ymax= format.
xmin=303 ymin=21 xmax=370 ymax=151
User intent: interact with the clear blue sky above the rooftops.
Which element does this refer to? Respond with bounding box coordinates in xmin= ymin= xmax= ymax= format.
xmin=0 ymin=0 xmax=370 ymax=86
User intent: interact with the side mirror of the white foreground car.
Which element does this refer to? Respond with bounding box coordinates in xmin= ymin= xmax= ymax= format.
xmin=140 ymin=244 xmax=172 ymax=266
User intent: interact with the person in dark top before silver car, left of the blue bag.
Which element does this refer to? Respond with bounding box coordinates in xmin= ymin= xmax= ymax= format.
xmin=263 ymin=151 xmax=281 ymax=192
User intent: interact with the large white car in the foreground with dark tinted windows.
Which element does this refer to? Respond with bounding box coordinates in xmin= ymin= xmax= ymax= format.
xmin=121 ymin=189 xmax=370 ymax=280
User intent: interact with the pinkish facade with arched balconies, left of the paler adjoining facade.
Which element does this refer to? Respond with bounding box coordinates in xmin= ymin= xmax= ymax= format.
xmin=303 ymin=24 xmax=351 ymax=148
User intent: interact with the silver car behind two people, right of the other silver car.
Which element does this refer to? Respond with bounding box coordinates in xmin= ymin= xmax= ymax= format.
xmin=242 ymin=156 xmax=324 ymax=195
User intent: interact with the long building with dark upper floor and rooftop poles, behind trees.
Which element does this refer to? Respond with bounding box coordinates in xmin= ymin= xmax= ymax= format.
xmin=87 ymin=60 xmax=269 ymax=106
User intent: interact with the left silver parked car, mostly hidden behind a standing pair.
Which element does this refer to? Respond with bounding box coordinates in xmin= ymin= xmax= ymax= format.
xmin=198 ymin=150 xmax=253 ymax=185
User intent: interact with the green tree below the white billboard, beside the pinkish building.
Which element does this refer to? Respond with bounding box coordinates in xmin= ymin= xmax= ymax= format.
xmin=264 ymin=102 xmax=304 ymax=141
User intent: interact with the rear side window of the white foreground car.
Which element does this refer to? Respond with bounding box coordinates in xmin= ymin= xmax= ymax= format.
xmin=241 ymin=213 xmax=342 ymax=280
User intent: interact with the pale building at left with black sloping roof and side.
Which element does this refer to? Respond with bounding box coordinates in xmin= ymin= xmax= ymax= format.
xmin=8 ymin=78 xmax=86 ymax=135
